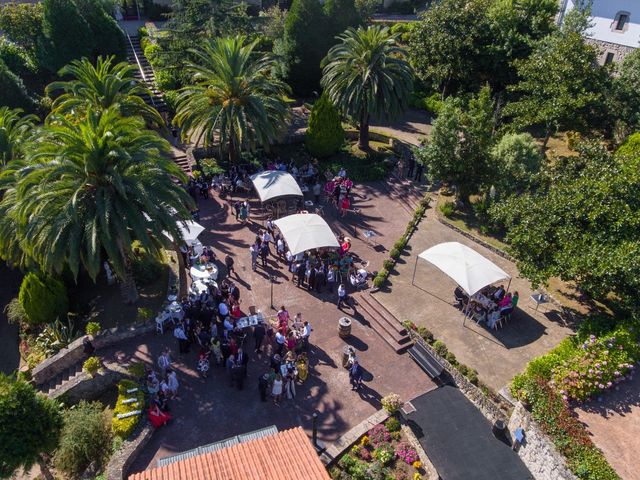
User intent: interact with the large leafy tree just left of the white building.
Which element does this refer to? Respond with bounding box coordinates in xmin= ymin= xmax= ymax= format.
xmin=504 ymin=8 xmax=608 ymax=148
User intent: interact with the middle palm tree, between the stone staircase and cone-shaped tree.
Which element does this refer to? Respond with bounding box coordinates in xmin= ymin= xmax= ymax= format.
xmin=175 ymin=36 xmax=288 ymax=162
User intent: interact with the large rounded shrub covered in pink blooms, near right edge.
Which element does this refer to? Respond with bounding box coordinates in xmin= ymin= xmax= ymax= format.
xmin=551 ymin=329 xmax=639 ymax=401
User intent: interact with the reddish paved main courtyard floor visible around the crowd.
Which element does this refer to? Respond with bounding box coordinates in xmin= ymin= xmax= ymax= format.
xmin=120 ymin=182 xmax=435 ymax=472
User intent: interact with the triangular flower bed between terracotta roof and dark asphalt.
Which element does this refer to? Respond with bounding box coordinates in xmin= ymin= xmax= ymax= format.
xmin=330 ymin=416 xmax=427 ymax=480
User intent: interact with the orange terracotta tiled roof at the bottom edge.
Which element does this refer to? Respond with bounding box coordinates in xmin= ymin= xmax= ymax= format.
xmin=129 ymin=427 xmax=330 ymax=480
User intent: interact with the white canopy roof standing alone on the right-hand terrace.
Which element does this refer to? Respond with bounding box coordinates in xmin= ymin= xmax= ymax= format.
xmin=418 ymin=242 xmax=511 ymax=295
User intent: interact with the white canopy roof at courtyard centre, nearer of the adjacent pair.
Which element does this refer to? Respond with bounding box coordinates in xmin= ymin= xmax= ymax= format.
xmin=274 ymin=213 xmax=340 ymax=255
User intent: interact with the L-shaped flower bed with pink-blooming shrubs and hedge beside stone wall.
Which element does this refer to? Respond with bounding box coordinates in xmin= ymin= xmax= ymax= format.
xmin=511 ymin=318 xmax=640 ymax=480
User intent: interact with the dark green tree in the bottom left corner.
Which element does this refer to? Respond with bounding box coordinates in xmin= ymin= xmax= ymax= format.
xmin=0 ymin=374 xmax=63 ymax=479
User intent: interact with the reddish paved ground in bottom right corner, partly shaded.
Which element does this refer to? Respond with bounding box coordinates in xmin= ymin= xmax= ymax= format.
xmin=576 ymin=375 xmax=640 ymax=480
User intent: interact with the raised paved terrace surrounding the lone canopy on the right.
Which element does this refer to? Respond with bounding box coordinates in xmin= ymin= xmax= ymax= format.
xmin=375 ymin=210 xmax=571 ymax=390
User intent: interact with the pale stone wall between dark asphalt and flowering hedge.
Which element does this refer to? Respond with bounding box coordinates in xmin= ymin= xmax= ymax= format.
xmin=509 ymin=402 xmax=577 ymax=480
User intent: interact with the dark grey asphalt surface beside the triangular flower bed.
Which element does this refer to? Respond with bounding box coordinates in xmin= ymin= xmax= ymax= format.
xmin=405 ymin=385 xmax=533 ymax=480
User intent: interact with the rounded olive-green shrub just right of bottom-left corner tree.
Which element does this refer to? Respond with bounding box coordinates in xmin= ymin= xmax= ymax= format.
xmin=54 ymin=400 xmax=111 ymax=476
